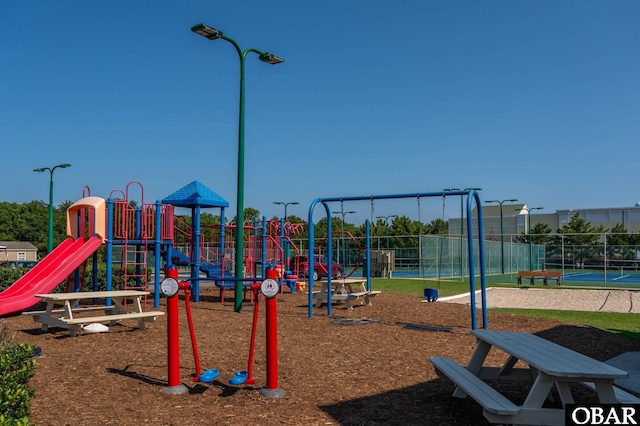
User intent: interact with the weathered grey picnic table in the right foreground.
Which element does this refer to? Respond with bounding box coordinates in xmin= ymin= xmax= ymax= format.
xmin=431 ymin=330 xmax=640 ymax=425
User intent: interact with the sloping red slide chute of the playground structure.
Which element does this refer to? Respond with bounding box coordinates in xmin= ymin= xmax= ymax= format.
xmin=0 ymin=237 xmax=102 ymax=315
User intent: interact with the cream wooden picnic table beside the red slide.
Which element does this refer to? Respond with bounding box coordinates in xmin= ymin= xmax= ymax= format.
xmin=23 ymin=290 xmax=164 ymax=336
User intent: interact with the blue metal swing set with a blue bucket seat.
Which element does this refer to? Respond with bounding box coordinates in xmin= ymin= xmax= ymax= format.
xmin=307 ymin=189 xmax=488 ymax=330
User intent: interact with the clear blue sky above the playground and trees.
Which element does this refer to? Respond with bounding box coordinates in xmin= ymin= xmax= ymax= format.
xmin=0 ymin=0 xmax=640 ymax=222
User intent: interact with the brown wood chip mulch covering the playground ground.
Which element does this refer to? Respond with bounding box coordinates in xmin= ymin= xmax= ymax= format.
xmin=0 ymin=287 xmax=640 ymax=426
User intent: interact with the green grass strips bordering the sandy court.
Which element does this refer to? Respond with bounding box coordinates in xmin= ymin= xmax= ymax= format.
xmin=371 ymin=278 xmax=640 ymax=341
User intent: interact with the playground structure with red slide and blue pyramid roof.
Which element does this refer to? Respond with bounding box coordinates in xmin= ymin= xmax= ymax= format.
xmin=0 ymin=181 xmax=301 ymax=315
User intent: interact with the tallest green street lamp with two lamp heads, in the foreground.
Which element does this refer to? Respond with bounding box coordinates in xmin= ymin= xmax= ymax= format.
xmin=191 ymin=20 xmax=284 ymax=312
